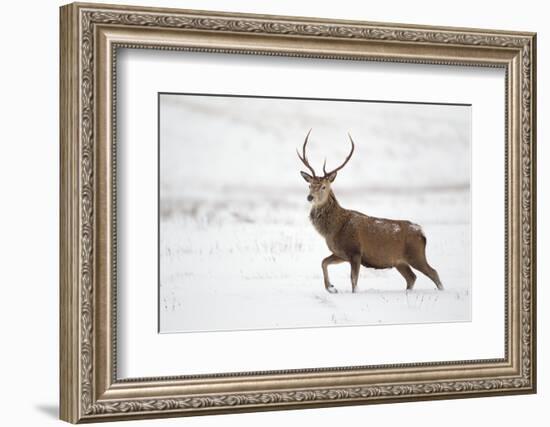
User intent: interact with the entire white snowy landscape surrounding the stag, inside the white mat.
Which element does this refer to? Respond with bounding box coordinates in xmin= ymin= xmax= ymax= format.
xmin=159 ymin=95 xmax=472 ymax=332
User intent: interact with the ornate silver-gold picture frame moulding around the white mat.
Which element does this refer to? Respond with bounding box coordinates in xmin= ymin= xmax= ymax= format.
xmin=60 ymin=3 xmax=536 ymax=423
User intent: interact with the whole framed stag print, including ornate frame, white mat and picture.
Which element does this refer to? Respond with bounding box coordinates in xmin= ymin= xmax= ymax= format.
xmin=60 ymin=4 xmax=536 ymax=423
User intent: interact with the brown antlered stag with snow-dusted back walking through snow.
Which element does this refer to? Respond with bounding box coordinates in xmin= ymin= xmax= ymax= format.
xmin=297 ymin=130 xmax=443 ymax=293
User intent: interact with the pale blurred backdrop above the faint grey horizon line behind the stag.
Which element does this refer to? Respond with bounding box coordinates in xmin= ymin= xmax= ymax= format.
xmin=160 ymin=95 xmax=471 ymax=201
